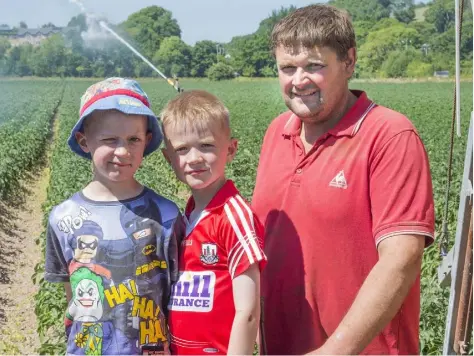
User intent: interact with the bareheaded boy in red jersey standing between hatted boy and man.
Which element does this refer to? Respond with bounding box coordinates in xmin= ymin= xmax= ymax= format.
xmin=161 ymin=90 xmax=266 ymax=355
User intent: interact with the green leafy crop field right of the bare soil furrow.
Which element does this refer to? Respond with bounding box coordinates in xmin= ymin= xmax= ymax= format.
xmin=31 ymin=80 xmax=472 ymax=354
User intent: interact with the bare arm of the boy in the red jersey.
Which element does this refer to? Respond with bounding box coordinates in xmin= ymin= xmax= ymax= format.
xmin=228 ymin=264 xmax=260 ymax=355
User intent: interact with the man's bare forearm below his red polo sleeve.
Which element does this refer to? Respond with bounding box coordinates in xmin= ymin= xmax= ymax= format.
xmin=312 ymin=235 xmax=425 ymax=355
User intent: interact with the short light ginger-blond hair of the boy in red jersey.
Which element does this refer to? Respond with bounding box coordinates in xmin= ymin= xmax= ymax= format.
xmin=160 ymin=90 xmax=230 ymax=137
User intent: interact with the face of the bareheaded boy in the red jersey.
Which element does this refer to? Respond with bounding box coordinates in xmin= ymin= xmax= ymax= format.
xmin=163 ymin=128 xmax=237 ymax=195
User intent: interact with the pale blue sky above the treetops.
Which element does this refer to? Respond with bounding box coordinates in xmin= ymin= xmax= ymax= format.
xmin=0 ymin=0 xmax=428 ymax=45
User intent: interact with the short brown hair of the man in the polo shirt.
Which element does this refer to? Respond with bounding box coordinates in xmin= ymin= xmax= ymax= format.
xmin=271 ymin=4 xmax=356 ymax=60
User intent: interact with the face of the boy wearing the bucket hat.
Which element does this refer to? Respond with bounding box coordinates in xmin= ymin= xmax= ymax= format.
xmin=76 ymin=111 xmax=151 ymax=182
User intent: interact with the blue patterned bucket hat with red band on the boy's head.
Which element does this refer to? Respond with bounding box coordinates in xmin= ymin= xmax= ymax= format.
xmin=68 ymin=77 xmax=163 ymax=159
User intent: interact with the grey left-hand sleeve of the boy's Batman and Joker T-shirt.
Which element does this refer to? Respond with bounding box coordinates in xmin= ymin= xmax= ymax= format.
xmin=44 ymin=222 xmax=69 ymax=282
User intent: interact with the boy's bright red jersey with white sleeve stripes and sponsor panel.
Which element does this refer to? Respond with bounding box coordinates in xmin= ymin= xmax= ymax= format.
xmin=168 ymin=180 xmax=266 ymax=355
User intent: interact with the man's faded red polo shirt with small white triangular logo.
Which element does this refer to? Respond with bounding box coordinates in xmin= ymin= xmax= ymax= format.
xmin=252 ymin=91 xmax=434 ymax=354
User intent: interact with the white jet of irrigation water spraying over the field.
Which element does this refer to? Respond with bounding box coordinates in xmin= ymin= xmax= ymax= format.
xmin=69 ymin=0 xmax=175 ymax=86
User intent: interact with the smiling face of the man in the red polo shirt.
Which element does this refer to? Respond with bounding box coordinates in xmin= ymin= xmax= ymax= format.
xmin=275 ymin=46 xmax=355 ymax=123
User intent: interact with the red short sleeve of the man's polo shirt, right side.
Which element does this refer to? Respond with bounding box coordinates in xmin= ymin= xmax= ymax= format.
xmin=370 ymin=130 xmax=434 ymax=246
